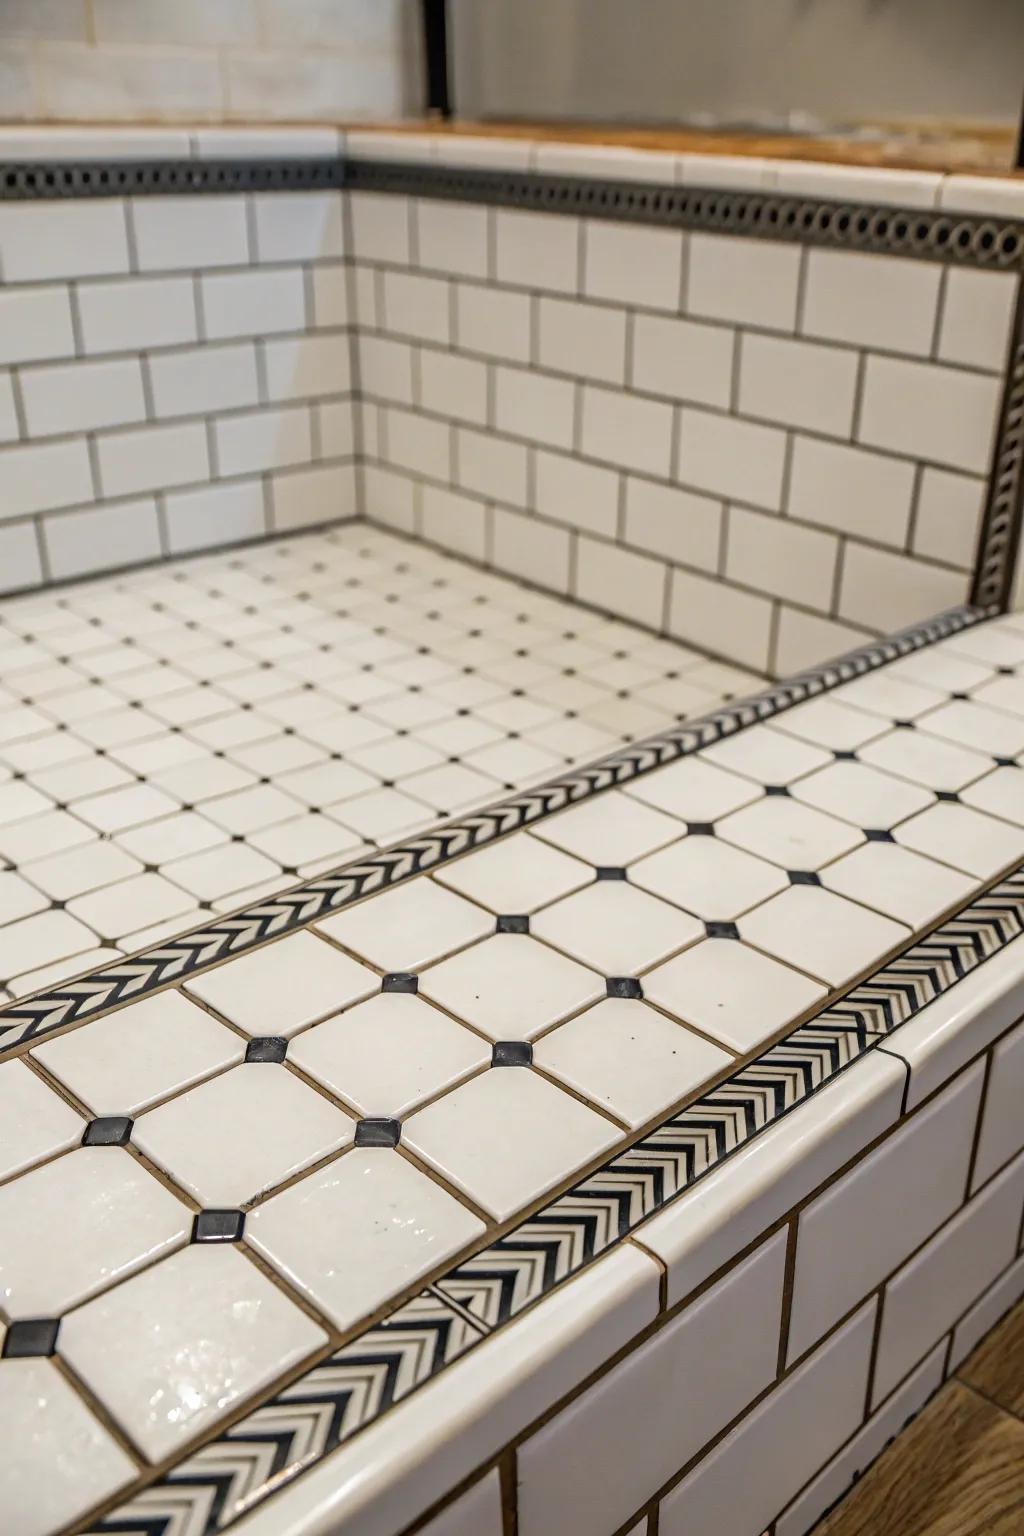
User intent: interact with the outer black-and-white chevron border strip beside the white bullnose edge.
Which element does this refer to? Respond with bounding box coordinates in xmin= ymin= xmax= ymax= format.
xmin=84 ymin=863 xmax=1024 ymax=1536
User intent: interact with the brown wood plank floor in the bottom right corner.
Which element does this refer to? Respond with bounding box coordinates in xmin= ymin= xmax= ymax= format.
xmin=814 ymin=1303 xmax=1024 ymax=1536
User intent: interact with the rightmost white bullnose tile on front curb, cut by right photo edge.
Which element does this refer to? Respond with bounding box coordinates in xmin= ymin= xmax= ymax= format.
xmin=881 ymin=943 xmax=1024 ymax=1109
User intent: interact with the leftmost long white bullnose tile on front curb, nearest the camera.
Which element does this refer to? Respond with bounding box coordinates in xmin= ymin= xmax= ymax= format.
xmin=233 ymin=1244 xmax=660 ymax=1536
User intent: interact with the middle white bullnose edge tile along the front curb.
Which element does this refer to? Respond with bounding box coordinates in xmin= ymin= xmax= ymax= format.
xmin=637 ymin=1052 xmax=906 ymax=1307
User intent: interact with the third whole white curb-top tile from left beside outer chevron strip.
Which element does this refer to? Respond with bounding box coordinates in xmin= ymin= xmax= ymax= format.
xmin=402 ymin=1066 xmax=620 ymax=1221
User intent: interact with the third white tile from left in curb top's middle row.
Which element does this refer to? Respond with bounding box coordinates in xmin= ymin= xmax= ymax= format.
xmin=289 ymin=992 xmax=491 ymax=1120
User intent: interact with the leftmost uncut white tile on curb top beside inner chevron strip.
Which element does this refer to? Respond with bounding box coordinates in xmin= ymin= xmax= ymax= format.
xmin=34 ymin=991 xmax=244 ymax=1115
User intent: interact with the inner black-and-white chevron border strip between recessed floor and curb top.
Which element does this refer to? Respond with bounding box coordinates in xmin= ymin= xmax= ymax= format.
xmin=0 ymin=607 xmax=995 ymax=1058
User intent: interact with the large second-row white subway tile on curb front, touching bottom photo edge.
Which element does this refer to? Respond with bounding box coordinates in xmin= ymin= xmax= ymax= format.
xmin=659 ymin=1299 xmax=877 ymax=1536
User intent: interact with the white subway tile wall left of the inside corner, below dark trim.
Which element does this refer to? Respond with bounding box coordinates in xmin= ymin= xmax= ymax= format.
xmin=0 ymin=181 xmax=356 ymax=591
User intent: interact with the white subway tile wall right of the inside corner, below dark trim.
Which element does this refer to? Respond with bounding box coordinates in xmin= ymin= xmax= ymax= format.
xmin=352 ymin=181 xmax=1016 ymax=673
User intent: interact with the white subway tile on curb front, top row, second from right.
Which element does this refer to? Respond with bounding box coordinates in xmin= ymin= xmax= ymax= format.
xmin=788 ymin=1066 xmax=983 ymax=1362
